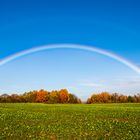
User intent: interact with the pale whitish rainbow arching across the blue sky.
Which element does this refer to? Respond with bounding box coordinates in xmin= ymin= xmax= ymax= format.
xmin=0 ymin=44 xmax=140 ymax=74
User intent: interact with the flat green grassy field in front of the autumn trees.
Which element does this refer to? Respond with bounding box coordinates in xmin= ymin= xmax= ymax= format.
xmin=0 ymin=103 xmax=140 ymax=140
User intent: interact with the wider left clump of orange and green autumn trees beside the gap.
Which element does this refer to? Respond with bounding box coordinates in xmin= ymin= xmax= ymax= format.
xmin=0 ymin=89 xmax=81 ymax=104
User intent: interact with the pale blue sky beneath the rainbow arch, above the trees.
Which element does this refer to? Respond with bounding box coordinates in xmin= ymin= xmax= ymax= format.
xmin=0 ymin=49 xmax=140 ymax=100
